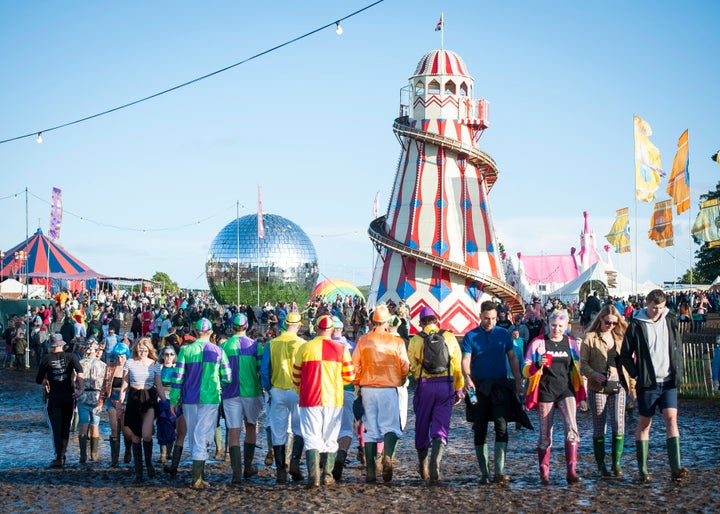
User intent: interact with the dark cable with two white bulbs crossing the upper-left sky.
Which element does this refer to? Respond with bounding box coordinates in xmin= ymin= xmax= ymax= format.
xmin=0 ymin=0 xmax=385 ymax=144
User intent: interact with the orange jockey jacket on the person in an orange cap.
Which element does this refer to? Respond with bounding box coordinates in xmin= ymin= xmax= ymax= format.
xmin=353 ymin=329 xmax=410 ymax=387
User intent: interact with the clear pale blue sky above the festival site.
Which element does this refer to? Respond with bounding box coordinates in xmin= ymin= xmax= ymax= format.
xmin=0 ymin=0 xmax=720 ymax=287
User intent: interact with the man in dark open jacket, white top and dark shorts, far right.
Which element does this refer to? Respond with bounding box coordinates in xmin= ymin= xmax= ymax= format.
xmin=620 ymin=289 xmax=690 ymax=482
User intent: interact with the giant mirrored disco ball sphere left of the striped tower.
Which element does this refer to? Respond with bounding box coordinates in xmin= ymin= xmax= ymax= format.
xmin=205 ymin=214 xmax=318 ymax=305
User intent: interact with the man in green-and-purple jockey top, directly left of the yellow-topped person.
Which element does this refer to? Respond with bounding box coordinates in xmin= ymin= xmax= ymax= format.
xmin=221 ymin=314 xmax=263 ymax=484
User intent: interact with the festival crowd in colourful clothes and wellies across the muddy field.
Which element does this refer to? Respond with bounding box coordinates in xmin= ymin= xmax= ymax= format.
xmin=19 ymin=290 xmax=710 ymax=489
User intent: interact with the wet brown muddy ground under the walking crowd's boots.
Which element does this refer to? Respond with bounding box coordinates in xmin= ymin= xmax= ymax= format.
xmin=0 ymin=369 xmax=720 ymax=513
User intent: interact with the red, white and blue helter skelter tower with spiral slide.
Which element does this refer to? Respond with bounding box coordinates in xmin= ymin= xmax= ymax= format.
xmin=368 ymin=50 xmax=524 ymax=334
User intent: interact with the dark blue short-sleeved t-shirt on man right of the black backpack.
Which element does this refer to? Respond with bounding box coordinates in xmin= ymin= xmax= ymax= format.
xmin=461 ymin=326 xmax=513 ymax=380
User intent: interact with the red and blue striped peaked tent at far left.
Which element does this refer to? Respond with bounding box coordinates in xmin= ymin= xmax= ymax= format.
xmin=0 ymin=229 xmax=104 ymax=291
